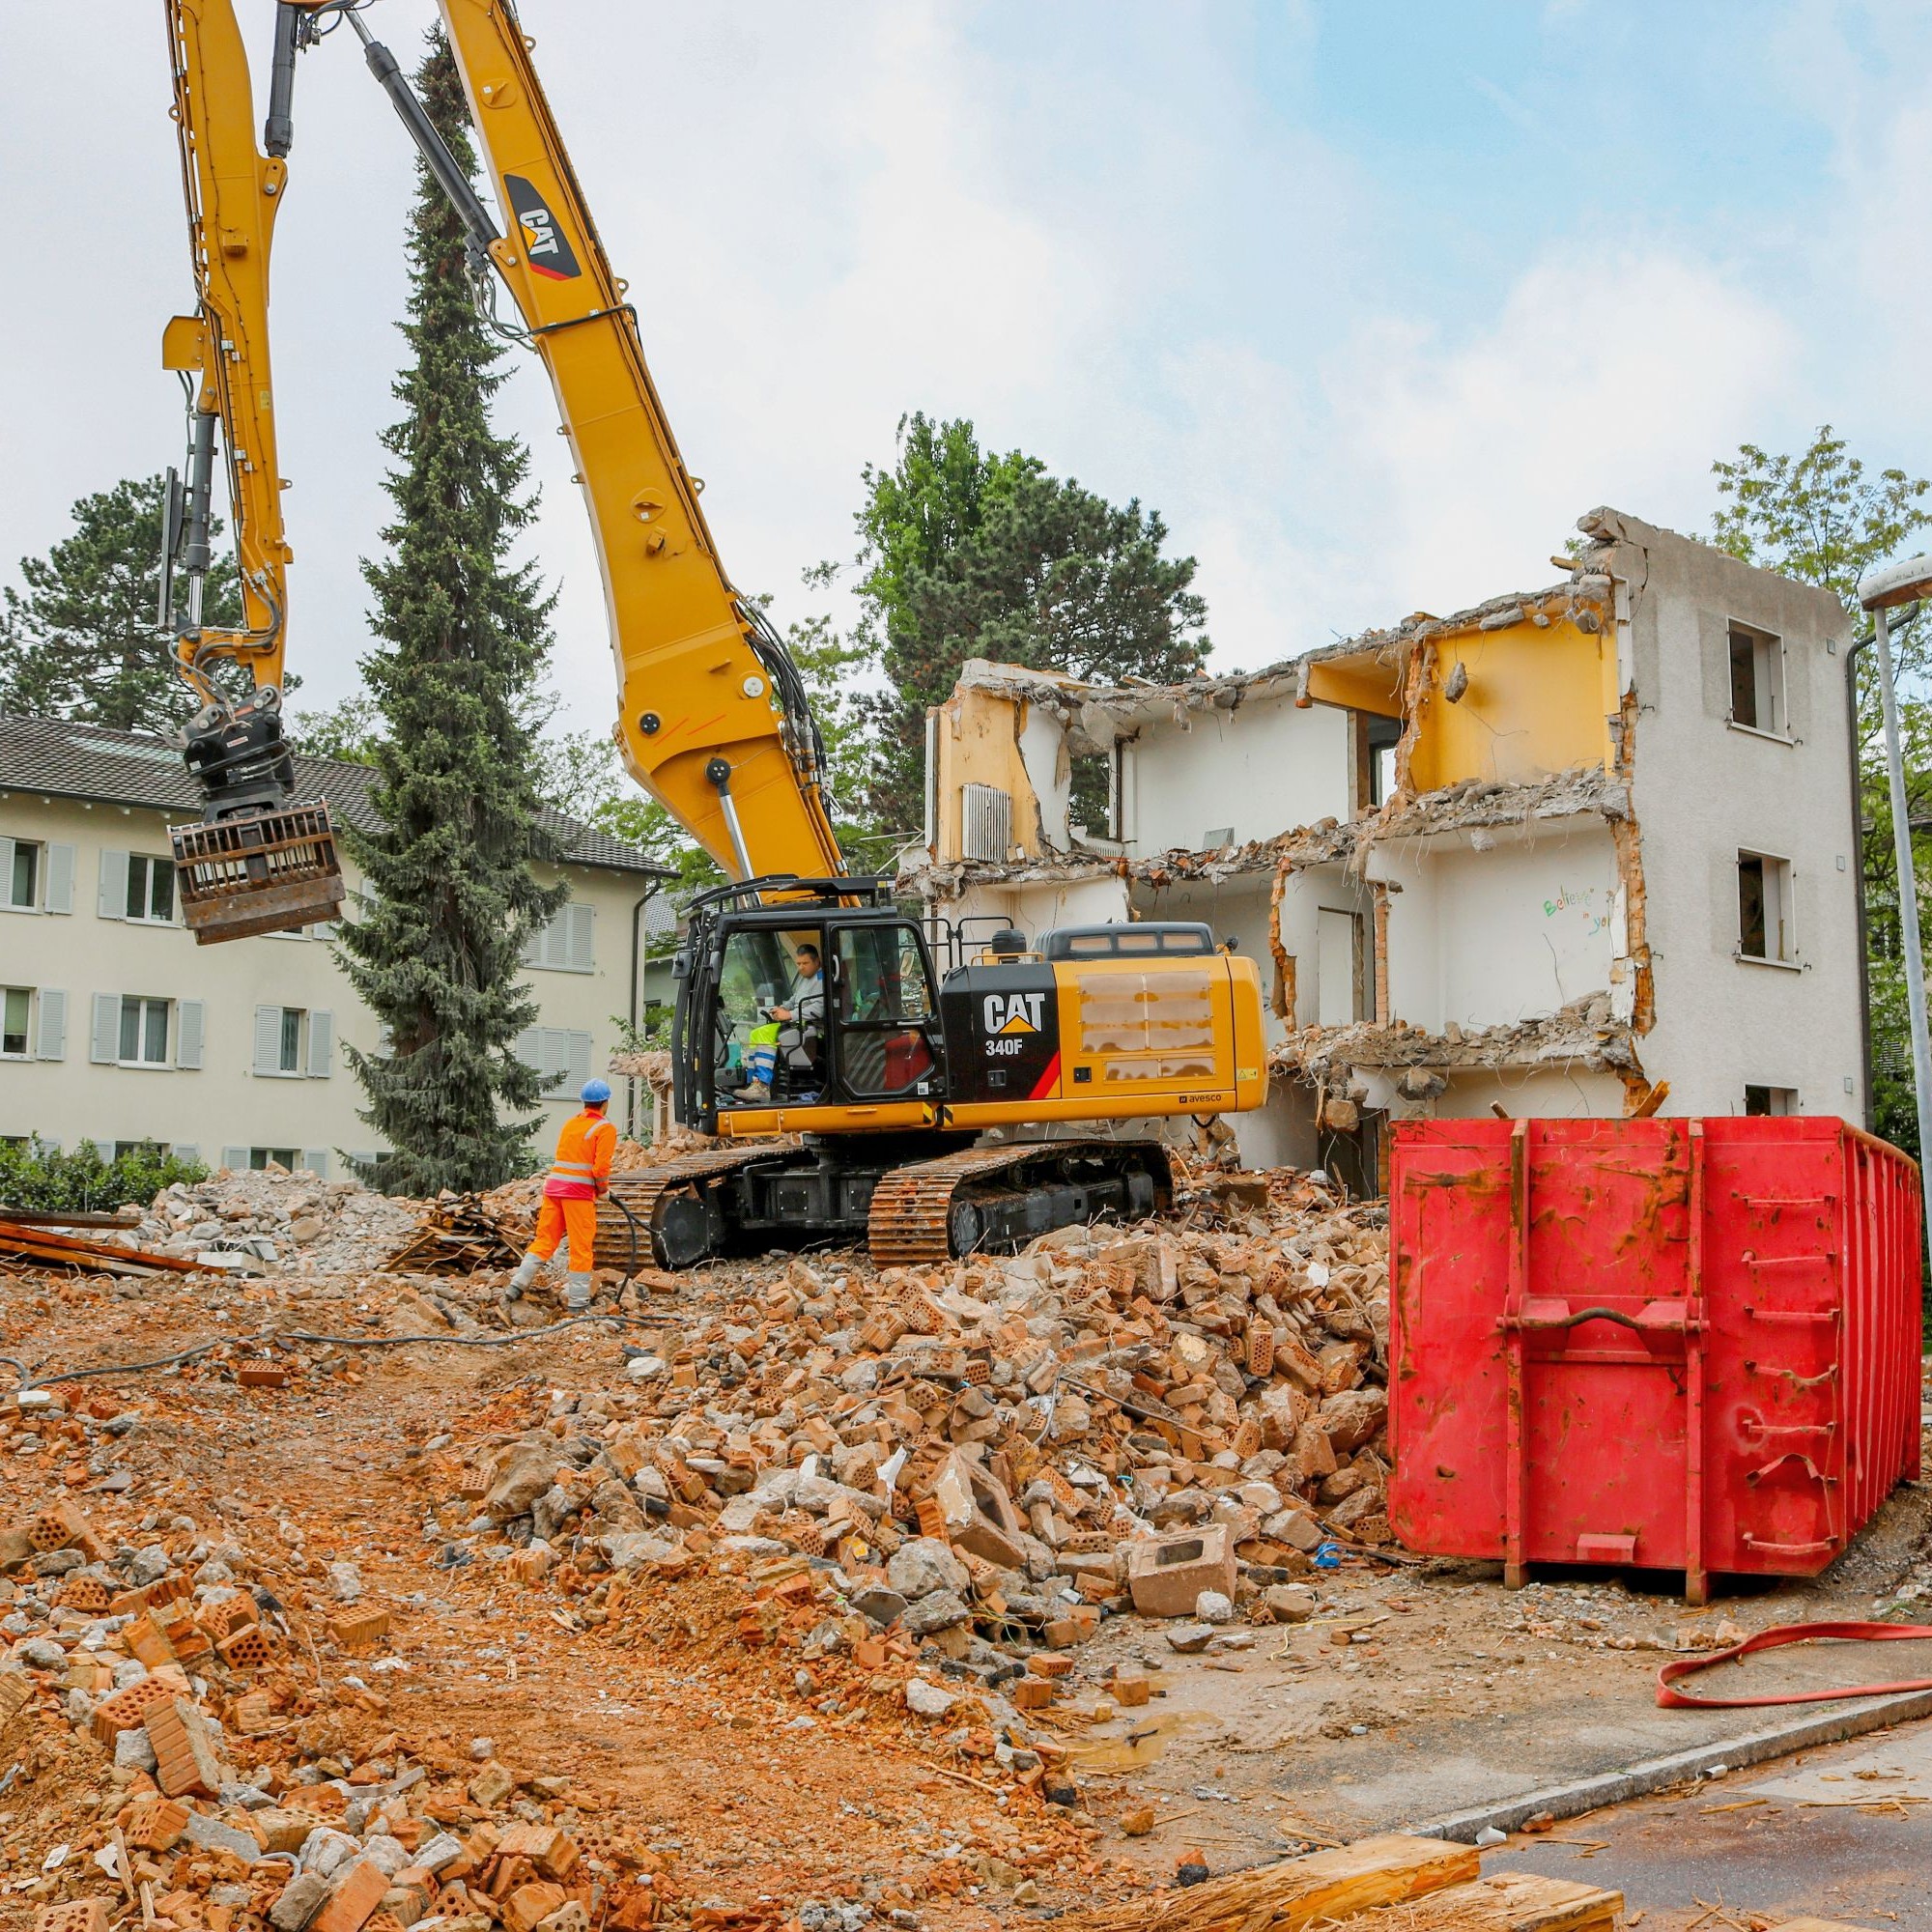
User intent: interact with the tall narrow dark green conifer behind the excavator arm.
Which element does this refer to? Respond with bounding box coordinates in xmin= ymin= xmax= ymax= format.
xmin=344 ymin=33 xmax=566 ymax=1194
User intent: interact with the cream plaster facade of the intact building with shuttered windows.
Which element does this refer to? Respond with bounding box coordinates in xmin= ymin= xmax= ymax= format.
xmin=0 ymin=792 xmax=645 ymax=1173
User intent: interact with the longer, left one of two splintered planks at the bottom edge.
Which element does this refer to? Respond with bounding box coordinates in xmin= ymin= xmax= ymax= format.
xmin=1059 ymin=1835 xmax=1480 ymax=1932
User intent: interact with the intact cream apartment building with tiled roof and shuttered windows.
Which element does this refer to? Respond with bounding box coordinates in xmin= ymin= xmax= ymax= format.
xmin=0 ymin=719 xmax=667 ymax=1175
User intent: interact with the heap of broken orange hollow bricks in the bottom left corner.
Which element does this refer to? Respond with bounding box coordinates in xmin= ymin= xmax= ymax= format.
xmin=0 ymin=1484 xmax=667 ymax=1932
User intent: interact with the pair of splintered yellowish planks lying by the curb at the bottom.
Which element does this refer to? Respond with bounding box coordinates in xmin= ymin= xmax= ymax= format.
xmin=1061 ymin=1837 xmax=1623 ymax=1932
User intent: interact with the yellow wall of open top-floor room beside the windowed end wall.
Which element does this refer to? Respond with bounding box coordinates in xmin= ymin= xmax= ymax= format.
xmin=1408 ymin=618 xmax=1617 ymax=792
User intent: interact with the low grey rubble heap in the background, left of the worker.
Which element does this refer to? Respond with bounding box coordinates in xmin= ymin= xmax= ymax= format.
xmin=131 ymin=1165 xmax=421 ymax=1275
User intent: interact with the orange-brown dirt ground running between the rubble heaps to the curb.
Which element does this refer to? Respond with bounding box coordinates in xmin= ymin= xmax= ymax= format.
xmin=0 ymin=1252 xmax=1932 ymax=1932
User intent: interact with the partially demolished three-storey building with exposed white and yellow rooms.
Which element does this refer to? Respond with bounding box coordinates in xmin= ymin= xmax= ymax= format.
xmin=904 ymin=510 xmax=1866 ymax=1188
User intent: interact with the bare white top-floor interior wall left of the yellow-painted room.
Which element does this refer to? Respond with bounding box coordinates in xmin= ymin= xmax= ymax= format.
xmin=1124 ymin=697 xmax=1349 ymax=858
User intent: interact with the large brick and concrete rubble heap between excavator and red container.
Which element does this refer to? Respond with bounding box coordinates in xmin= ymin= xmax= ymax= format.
xmin=442 ymin=1173 xmax=1389 ymax=1692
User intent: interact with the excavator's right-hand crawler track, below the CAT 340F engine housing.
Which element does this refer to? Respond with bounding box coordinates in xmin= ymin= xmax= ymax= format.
xmin=866 ymin=1140 xmax=1175 ymax=1267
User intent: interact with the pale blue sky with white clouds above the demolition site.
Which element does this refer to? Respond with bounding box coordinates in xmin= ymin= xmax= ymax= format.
xmin=0 ymin=0 xmax=1932 ymax=734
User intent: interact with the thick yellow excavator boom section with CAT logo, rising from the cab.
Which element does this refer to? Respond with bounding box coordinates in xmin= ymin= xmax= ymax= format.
xmin=338 ymin=0 xmax=846 ymax=879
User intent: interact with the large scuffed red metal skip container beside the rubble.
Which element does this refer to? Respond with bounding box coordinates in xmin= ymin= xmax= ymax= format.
xmin=1389 ymin=1117 xmax=1920 ymax=1604
